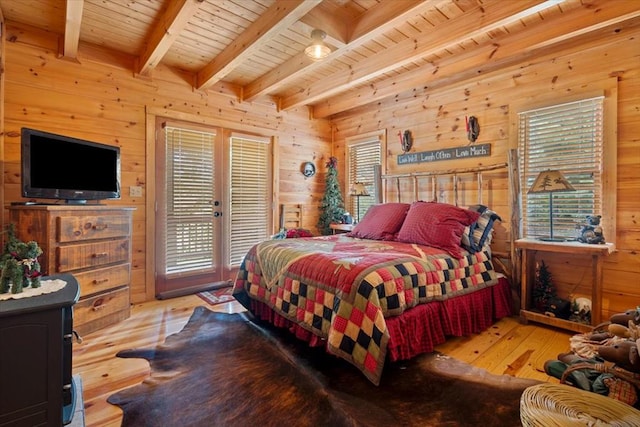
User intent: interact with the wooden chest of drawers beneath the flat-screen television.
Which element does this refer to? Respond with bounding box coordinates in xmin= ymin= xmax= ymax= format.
xmin=10 ymin=205 xmax=134 ymax=335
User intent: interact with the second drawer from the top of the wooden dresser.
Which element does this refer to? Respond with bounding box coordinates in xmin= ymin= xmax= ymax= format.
xmin=56 ymin=239 xmax=129 ymax=273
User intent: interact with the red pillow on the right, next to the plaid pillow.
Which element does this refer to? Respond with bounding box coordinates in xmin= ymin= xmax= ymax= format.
xmin=396 ymin=202 xmax=480 ymax=258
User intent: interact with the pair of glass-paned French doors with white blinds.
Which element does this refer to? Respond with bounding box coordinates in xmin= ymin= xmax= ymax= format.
xmin=155 ymin=122 xmax=272 ymax=298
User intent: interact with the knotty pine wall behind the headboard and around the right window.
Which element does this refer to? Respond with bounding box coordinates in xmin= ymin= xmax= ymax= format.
xmin=332 ymin=28 xmax=640 ymax=319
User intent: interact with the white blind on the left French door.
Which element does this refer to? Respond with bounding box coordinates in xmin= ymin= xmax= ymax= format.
xmin=165 ymin=126 xmax=215 ymax=275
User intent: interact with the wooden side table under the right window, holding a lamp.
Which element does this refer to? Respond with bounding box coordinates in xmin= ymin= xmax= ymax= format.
xmin=515 ymin=238 xmax=615 ymax=332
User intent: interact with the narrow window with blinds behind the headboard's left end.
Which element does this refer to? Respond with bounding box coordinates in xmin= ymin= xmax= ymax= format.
xmin=347 ymin=135 xmax=382 ymax=219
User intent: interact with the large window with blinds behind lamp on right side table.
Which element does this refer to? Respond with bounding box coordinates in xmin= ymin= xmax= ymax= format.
xmin=518 ymin=97 xmax=604 ymax=239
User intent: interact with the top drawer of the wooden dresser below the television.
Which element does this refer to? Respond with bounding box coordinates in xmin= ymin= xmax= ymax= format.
xmin=56 ymin=215 xmax=131 ymax=243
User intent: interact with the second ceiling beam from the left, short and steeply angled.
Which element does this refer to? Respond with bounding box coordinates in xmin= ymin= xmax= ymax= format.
xmin=135 ymin=0 xmax=204 ymax=74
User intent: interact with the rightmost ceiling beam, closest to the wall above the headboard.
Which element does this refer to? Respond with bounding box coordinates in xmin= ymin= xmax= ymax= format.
xmin=313 ymin=2 xmax=640 ymax=118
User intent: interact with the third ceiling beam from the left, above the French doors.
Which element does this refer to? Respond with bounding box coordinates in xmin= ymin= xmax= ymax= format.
xmin=197 ymin=0 xmax=322 ymax=89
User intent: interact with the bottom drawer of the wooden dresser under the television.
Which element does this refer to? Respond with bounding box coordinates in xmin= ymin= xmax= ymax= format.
xmin=73 ymin=286 xmax=131 ymax=335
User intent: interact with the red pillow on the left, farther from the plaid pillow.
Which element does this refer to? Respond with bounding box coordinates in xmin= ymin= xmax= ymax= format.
xmin=347 ymin=203 xmax=410 ymax=240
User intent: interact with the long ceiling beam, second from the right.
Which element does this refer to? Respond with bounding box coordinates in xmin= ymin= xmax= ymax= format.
xmin=280 ymin=0 xmax=558 ymax=110
